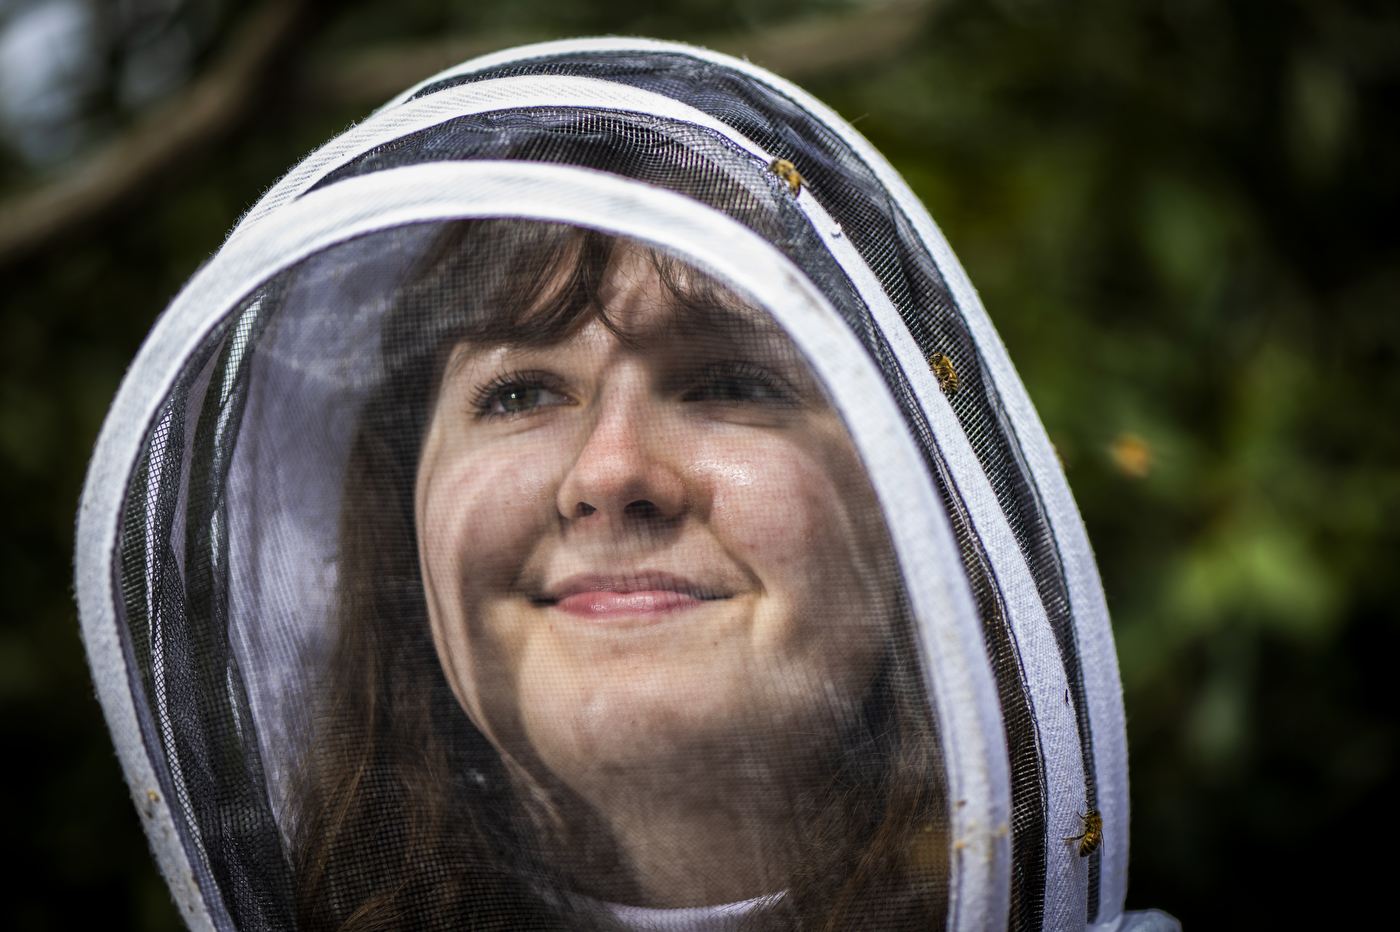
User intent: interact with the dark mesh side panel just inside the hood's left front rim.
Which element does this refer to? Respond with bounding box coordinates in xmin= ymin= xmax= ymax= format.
xmin=116 ymin=295 xmax=293 ymax=929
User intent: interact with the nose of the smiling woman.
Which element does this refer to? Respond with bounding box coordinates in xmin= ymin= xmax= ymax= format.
xmin=556 ymin=388 xmax=686 ymax=521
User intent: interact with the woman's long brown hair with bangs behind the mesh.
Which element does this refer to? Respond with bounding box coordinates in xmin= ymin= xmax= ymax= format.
xmin=293 ymin=220 xmax=948 ymax=932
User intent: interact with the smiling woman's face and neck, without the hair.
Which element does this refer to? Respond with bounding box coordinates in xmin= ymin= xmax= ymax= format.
xmin=414 ymin=246 xmax=895 ymax=908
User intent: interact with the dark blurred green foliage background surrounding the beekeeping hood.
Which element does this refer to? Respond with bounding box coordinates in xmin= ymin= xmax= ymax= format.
xmin=0 ymin=0 xmax=1400 ymax=932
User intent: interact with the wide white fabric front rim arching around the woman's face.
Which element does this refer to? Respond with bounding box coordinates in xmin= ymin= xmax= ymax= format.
xmin=78 ymin=162 xmax=1009 ymax=929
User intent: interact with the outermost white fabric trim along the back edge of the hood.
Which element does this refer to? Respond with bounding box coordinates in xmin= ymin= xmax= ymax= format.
xmin=389 ymin=38 xmax=1128 ymax=922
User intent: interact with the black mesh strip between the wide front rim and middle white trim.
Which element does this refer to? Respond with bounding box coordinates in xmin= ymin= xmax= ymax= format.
xmin=318 ymin=95 xmax=1058 ymax=929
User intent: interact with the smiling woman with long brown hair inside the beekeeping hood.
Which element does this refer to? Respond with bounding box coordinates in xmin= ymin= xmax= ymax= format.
xmin=298 ymin=221 xmax=946 ymax=929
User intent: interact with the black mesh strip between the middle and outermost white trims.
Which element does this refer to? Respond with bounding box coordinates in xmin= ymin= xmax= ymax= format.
xmin=417 ymin=52 xmax=1100 ymax=929
